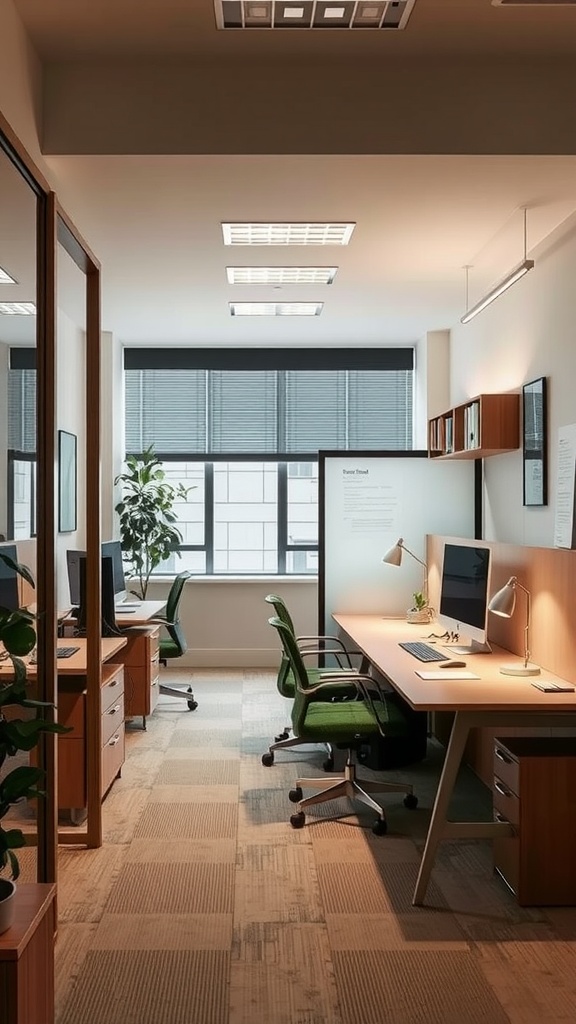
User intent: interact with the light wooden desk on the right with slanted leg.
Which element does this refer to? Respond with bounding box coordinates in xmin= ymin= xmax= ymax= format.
xmin=332 ymin=614 xmax=576 ymax=904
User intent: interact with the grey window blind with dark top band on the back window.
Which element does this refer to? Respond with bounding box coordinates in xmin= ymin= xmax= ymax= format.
xmin=124 ymin=349 xmax=413 ymax=456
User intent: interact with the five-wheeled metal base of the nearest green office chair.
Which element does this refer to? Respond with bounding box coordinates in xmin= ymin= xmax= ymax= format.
xmin=288 ymin=750 xmax=418 ymax=836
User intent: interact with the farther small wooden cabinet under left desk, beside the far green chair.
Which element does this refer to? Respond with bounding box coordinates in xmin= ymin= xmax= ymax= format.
xmin=118 ymin=626 xmax=160 ymax=729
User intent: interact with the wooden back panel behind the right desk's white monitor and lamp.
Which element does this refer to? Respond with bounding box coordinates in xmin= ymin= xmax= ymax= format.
xmin=426 ymin=535 xmax=576 ymax=785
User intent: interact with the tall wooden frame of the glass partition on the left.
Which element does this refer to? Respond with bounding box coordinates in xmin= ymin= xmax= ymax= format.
xmin=0 ymin=113 xmax=102 ymax=882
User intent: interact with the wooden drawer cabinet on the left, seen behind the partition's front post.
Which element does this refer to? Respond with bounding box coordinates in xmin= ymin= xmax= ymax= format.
xmin=57 ymin=662 xmax=124 ymax=809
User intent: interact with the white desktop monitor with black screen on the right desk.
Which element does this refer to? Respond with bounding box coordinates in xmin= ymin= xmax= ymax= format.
xmin=437 ymin=541 xmax=491 ymax=654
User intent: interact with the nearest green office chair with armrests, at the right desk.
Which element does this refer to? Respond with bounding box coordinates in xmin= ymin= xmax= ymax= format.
xmin=262 ymin=615 xmax=418 ymax=836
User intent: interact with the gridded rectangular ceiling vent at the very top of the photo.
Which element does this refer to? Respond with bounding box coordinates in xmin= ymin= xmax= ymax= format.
xmin=214 ymin=0 xmax=416 ymax=30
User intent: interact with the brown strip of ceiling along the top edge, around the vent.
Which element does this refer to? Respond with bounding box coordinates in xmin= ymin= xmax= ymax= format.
xmin=11 ymin=0 xmax=576 ymax=60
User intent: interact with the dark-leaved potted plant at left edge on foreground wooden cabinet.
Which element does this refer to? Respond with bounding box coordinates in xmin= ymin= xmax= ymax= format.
xmin=0 ymin=552 xmax=68 ymax=933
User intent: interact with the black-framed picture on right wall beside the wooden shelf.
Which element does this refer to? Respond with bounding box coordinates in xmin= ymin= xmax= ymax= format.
xmin=522 ymin=377 xmax=548 ymax=505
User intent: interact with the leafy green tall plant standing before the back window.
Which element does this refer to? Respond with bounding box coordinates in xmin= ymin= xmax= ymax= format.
xmin=114 ymin=445 xmax=192 ymax=601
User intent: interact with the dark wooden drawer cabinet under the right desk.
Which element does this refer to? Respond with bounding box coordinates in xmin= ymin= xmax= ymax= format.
xmin=493 ymin=736 xmax=576 ymax=906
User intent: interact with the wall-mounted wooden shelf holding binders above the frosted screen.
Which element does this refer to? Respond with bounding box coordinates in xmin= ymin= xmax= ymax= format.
xmin=428 ymin=394 xmax=520 ymax=459
